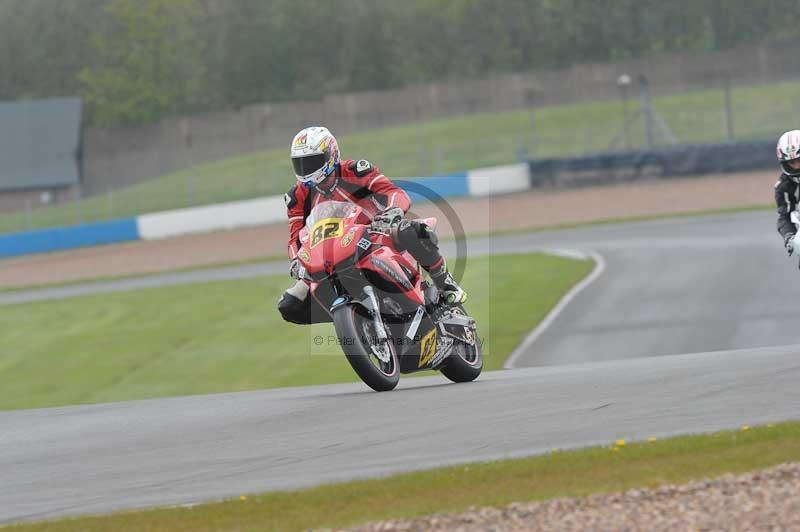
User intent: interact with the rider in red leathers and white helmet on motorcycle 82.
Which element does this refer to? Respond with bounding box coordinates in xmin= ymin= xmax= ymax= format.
xmin=278 ymin=126 xmax=466 ymax=324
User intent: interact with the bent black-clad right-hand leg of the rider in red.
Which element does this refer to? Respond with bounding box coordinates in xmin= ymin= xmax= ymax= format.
xmin=395 ymin=220 xmax=467 ymax=303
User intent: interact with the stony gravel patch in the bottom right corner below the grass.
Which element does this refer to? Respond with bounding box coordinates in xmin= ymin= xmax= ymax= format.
xmin=340 ymin=463 xmax=800 ymax=532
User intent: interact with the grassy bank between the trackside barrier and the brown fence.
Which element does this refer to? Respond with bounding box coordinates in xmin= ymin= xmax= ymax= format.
xmin=0 ymin=77 xmax=800 ymax=233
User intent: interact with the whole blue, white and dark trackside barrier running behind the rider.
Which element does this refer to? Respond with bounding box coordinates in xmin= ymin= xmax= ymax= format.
xmin=0 ymin=148 xmax=775 ymax=257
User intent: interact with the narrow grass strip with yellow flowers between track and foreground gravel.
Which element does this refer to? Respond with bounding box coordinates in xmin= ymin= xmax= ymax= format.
xmin=8 ymin=422 xmax=800 ymax=532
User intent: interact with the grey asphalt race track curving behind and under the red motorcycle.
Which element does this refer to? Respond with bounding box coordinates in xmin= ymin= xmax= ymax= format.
xmin=0 ymin=212 xmax=800 ymax=522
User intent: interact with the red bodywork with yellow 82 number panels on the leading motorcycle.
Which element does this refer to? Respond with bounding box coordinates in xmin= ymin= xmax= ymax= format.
xmin=298 ymin=203 xmax=468 ymax=373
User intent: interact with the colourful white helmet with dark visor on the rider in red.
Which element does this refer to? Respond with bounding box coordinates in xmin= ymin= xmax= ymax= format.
xmin=290 ymin=126 xmax=339 ymax=188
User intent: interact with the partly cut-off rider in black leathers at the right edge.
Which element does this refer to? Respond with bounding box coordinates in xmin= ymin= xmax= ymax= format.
xmin=775 ymin=129 xmax=800 ymax=255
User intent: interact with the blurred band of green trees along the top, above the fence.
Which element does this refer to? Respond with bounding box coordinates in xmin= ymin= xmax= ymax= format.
xmin=0 ymin=0 xmax=800 ymax=125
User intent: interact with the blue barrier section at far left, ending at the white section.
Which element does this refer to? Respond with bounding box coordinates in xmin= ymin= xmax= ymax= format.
xmin=0 ymin=218 xmax=139 ymax=257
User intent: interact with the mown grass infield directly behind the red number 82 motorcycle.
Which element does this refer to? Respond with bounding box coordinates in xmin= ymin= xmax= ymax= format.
xmin=0 ymin=254 xmax=592 ymax=409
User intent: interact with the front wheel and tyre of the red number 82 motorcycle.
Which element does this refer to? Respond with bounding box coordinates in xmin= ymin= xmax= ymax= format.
xmin=333 ymin=305 xmax=400 ymax=392
